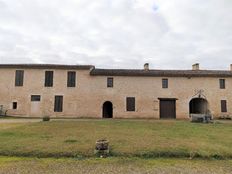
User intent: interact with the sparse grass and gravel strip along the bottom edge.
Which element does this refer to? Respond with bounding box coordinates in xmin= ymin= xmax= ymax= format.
xmin=0 ymin=157 xmax=232 ymax=174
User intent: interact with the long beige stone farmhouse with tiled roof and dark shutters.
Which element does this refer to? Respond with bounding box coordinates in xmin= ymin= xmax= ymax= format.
xmin=0 ymin=64 xmax=232 ymax=119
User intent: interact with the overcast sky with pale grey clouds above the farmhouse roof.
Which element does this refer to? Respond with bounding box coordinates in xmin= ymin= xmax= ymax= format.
xmin=0 ymin=0 xmax=232 ymax=69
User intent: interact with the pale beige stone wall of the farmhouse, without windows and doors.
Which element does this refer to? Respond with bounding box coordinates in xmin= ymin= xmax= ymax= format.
xmin=0 ymin=68 xmax=232 ymax=119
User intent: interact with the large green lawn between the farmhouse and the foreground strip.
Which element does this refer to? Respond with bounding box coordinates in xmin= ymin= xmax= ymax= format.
xmin=0 ymin=120 xmax=232 ymax=159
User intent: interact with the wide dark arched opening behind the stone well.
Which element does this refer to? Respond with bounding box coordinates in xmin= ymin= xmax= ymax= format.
xmin=189 ymin=98 xmax=209 ymax=114
